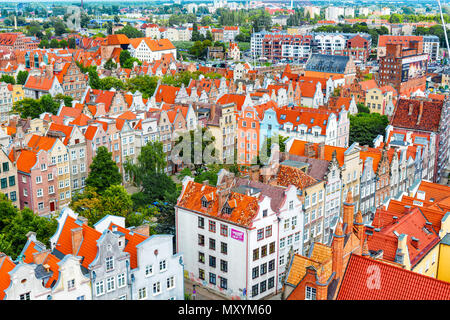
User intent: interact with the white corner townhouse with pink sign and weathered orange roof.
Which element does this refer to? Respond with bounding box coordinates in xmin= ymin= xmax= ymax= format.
xmin=175 ymin=170 xmax=302 ymax=300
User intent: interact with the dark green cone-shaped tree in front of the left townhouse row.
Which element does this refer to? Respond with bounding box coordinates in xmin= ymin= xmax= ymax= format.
xmin=86 ymin=146 xmax=122 ymax=195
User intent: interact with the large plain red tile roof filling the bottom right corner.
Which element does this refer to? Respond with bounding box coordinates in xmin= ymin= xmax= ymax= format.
xmin=337 ymin=254 xmax=450 ymax=300
